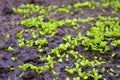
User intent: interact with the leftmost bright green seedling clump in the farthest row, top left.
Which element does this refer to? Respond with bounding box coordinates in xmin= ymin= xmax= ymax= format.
xmin=13 ymin=4 xmax=47 ymax=17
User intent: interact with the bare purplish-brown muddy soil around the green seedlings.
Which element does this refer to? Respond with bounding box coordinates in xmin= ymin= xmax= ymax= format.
xmin=0 ymin=0 xmax=120 ymax=80
